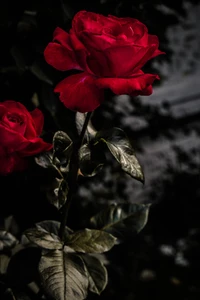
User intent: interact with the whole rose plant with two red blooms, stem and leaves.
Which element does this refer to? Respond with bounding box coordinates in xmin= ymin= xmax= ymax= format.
xmin=0 ymin=11 xmax=163 ymax=300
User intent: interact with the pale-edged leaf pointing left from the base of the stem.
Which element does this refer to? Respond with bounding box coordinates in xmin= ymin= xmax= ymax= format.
xmin=24 ymin=221 xmax=67 ymax=249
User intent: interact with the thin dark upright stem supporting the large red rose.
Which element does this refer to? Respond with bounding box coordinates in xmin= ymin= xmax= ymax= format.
xmin=59 ymin=112 xmax=92 ymax=241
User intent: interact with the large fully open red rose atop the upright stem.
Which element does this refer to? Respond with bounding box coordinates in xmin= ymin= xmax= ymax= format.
xmin=44 ymin=11 xmax=164 ymax=112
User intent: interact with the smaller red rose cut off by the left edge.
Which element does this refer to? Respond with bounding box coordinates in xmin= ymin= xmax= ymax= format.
xmin=0 ymin=100 xmax=52 ymax=175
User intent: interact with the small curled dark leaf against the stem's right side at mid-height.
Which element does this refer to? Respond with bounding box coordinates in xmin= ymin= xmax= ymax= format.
xmin=79 ymin=144 xmax=106 ymax=177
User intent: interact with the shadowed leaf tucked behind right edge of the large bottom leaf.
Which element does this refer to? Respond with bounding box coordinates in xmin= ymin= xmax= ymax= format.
xmin=79 ymin=254 xmax=108 ymax=295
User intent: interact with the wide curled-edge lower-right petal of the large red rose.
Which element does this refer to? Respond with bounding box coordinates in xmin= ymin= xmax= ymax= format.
xmin=96 ymin=71 xmax=159 ymax=96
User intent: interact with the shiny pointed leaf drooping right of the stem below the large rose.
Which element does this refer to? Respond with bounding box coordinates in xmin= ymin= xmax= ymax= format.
xmin=95 ymin=127 xmax=144 ymax=182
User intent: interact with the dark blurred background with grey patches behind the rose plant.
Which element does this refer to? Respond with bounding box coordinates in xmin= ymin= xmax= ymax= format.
xmin=0 ymin=0 xmax=200 ymax=300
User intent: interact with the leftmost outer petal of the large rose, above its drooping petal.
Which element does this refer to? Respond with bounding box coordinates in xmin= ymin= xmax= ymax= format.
xmin=44 ymin=27 xmax=81 ymax=71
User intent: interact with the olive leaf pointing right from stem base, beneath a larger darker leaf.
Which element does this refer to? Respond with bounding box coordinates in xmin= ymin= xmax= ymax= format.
xmin=67 ymin=228 xmax=116 ymax=253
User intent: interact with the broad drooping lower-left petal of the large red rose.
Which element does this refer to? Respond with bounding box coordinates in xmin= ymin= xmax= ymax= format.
xmin=54 ymin=72 xmax=103 ymax=112
